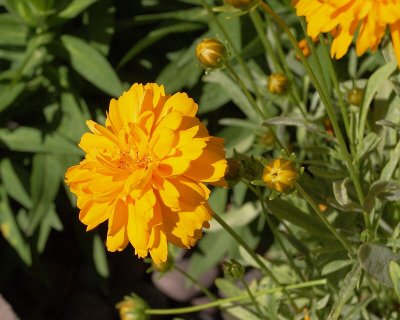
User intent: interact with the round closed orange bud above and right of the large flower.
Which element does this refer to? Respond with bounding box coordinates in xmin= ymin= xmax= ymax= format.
xmin=196 ymin=39 xmax=227 ymax=69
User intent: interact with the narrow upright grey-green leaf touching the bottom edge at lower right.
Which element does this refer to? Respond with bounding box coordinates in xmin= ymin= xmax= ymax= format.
xmin=327 ymin=263 xmax=362 ymax=320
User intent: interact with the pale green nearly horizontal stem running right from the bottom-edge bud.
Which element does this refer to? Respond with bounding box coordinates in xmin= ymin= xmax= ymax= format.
xmin=145 ymin=279 xmax=327 ymax=315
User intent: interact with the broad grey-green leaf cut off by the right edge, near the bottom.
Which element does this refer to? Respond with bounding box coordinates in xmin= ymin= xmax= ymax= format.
xmin=358 ymin=243 xmax=400 ymax=287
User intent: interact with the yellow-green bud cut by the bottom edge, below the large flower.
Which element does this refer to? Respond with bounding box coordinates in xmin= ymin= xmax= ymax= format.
xmin=116 ymin=293 xmax=149 ymax=320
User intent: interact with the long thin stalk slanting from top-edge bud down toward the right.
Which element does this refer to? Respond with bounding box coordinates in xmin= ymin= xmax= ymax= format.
xmin=261 ymin=1 xmax=370 ymax=210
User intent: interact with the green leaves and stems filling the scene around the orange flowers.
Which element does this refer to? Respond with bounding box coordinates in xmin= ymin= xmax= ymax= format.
xmin=0 ymin=0 xmax=400 ymax=319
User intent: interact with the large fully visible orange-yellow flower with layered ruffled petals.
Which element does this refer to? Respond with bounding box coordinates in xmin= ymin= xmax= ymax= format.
xmin=65 ymin=84 xmax=227 ymax=264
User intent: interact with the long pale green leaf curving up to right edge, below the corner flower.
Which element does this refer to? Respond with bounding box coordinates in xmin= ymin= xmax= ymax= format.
xmin=358 ymin=61 xmax=397 ymax=141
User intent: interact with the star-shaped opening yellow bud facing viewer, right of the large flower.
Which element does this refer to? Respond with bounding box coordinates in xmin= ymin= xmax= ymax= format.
xmin=262 ymin=158 xmax=299 ymax=193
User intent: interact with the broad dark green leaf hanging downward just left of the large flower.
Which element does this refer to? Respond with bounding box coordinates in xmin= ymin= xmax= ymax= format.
xmin=26 ymin=153 xmax=63 ymax=235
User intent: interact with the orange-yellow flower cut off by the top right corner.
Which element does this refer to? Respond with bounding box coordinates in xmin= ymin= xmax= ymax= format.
xmin=296 ymin=0 xmax=400 ymax=66
